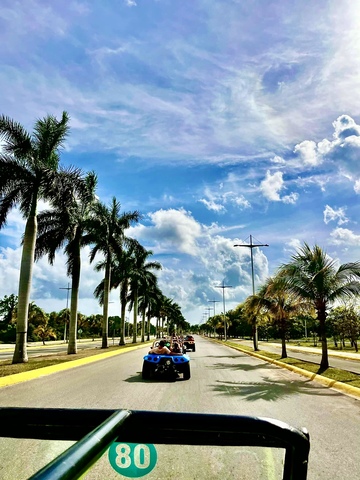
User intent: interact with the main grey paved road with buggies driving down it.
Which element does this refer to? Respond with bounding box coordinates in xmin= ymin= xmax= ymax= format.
xmin=0 ymin=336 xmax=360 ymax=480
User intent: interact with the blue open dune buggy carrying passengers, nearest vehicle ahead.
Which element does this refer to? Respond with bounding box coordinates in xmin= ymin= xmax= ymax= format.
xmin=142 ymin=353 xmax=190 ymax=382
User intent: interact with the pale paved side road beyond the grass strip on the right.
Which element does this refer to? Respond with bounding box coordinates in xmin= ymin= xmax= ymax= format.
xmin=231 ymin=339 xmax=360 ymax=374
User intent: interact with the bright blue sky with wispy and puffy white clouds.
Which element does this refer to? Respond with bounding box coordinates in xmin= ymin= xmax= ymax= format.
xmin=0 ymin=0 xmax=360 ymax=324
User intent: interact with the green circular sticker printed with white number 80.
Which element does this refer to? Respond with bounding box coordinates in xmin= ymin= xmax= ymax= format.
xmin=109 ymin=442 xmax=157 ymax=478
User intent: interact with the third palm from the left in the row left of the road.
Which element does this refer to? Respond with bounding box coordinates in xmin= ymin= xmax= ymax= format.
xmin=86 ymin=197 xmax=140 ymax=348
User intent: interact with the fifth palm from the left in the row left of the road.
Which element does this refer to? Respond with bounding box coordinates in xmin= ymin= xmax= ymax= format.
xmin=128 ymin=244 xmax=162 ymax=343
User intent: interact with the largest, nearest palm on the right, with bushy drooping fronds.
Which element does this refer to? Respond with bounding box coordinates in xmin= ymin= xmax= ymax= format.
xmin=279 ymin=243 xmax=360 ymax=370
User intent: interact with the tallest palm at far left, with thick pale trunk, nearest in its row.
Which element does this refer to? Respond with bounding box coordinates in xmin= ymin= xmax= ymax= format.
xmin=0 ymin=112 xmax=69 ymax=363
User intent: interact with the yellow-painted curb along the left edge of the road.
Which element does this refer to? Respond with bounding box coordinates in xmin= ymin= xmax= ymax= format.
xmin=0 ymin=342 xmax=151 ymax=388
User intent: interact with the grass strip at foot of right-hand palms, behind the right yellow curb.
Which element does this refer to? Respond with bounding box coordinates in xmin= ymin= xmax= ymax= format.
xmin=227 ymin=342 xmax=360 ymax=388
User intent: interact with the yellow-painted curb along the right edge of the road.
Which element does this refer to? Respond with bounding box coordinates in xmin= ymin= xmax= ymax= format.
xmin=215 ymin=340 xmax=360 ymax=398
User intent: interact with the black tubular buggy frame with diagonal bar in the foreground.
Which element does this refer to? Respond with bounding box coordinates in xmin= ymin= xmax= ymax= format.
xmin=0 ymin=408 xmax=310 ymax=480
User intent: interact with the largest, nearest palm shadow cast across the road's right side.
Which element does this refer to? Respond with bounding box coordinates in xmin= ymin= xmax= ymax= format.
xmin=212 ymin=377 xmax=342 ymax=402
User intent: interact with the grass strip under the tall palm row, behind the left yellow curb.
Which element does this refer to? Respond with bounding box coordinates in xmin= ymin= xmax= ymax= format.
xmin=0 ymin=344 xmax=145 ymax=377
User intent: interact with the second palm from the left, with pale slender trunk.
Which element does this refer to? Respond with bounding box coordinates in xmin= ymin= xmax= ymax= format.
xmin=35 ymin=172 xmax=97 ymax=354
